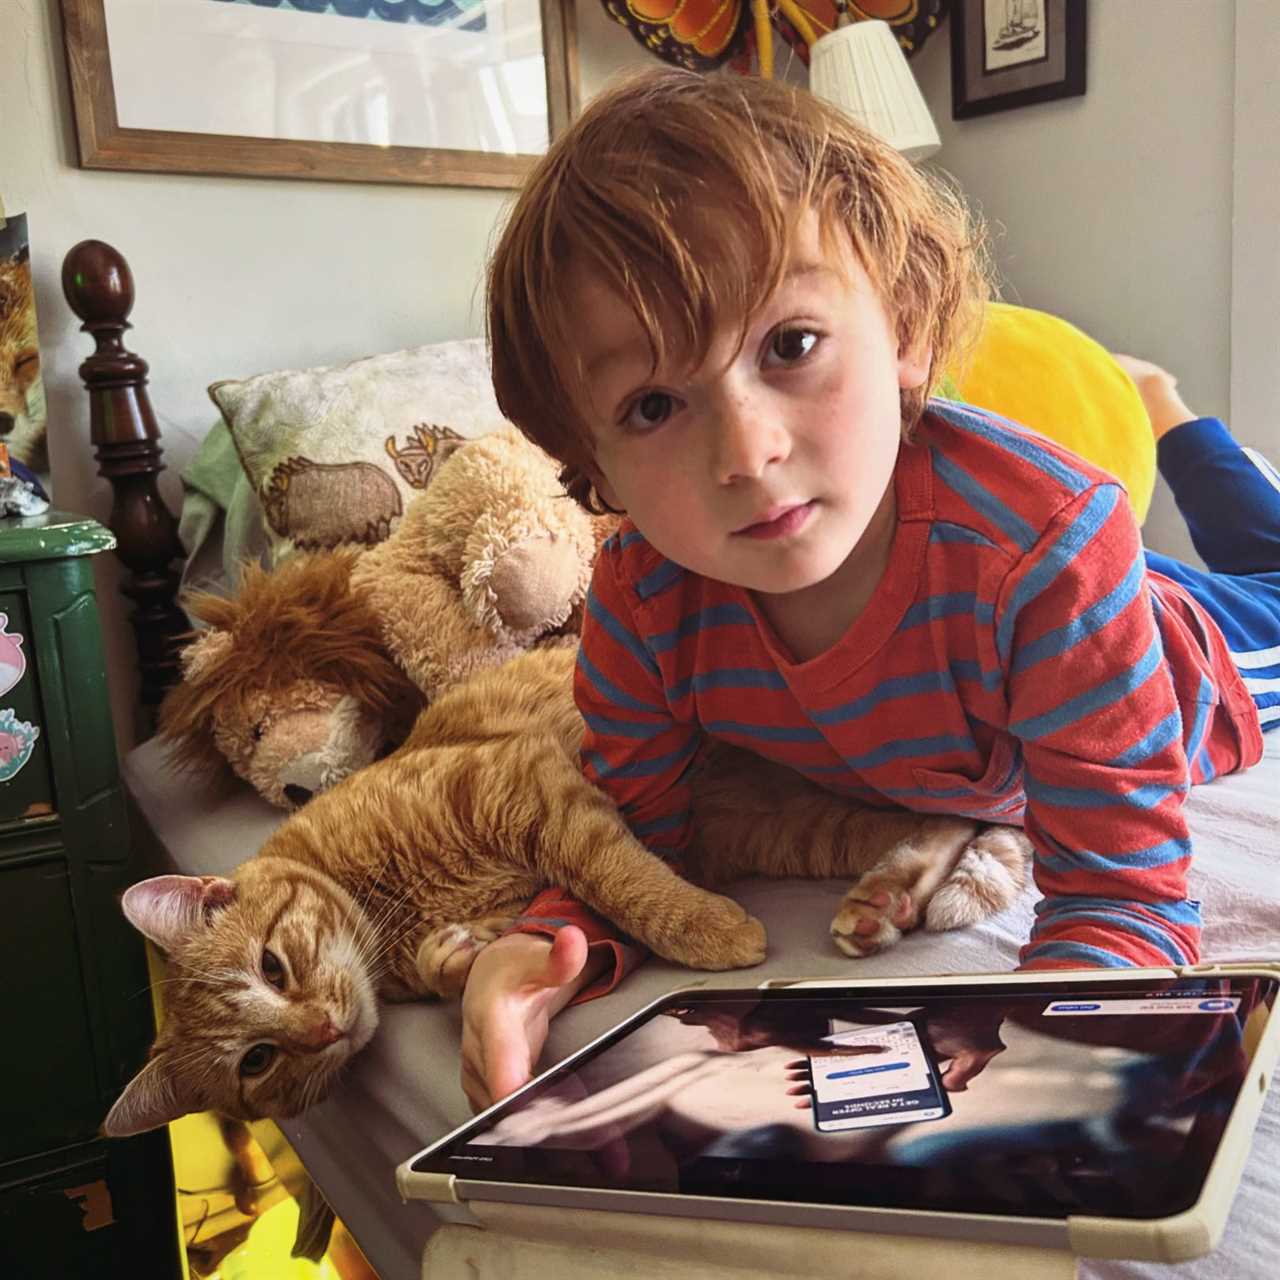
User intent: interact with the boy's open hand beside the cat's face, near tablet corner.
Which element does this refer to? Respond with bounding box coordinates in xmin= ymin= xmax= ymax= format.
xmin=462 ymin=925 xmax=605 ymax=1111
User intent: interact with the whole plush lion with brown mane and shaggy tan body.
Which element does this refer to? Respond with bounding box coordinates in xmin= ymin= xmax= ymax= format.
xmin=160 ymin=430 xmax=616 ymax=809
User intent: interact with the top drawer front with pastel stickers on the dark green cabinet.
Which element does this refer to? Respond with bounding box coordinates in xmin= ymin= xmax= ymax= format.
xmin=0 ymin=590 xmax=55 ymax=824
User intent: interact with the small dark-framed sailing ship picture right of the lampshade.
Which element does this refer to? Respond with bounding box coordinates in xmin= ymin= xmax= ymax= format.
xmin=951 ymin=0 xmax=1084 ymax=120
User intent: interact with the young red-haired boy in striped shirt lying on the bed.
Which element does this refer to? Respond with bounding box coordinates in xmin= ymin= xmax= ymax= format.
xmin=463 ymin=72 xmax=1280 ymax=1105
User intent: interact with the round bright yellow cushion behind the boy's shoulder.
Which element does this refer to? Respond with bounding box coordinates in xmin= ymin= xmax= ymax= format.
xmin=942 ymin=302 xmax=1156 ymax=524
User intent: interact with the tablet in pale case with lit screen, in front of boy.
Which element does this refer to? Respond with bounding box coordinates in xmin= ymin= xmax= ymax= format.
xmin=398 ymin=965 xmax=1280 ymax=1261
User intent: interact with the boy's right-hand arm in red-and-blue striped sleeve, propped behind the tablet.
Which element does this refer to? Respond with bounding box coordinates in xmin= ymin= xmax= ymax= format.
xmin=996 ymin=485 xmax=1208 ymax=969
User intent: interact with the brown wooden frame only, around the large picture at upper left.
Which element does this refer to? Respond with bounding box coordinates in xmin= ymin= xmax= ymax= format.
xmin=61 ymin=0 xmax=579 ymax=187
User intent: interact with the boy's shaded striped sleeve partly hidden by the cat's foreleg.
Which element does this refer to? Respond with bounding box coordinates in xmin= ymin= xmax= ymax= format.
xmin=508 ymin=539 xmax=699 ymax=1004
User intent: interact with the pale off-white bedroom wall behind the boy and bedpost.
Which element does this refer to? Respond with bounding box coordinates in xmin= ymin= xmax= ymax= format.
xmin=0 ymin=0 xmax=1264 ymax=739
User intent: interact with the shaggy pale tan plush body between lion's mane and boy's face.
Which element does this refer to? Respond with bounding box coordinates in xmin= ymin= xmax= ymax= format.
xmin=352 ymin=428 xmax=617 ymax=699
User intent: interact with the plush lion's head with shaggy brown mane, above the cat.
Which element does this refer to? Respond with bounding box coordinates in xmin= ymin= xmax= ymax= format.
xmin=160 ymin=552 xmax=422 ymax=809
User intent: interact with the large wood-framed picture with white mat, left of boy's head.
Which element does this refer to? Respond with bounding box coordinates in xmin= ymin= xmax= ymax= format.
xmin=61 ymin=0 xmax=577 ymax=187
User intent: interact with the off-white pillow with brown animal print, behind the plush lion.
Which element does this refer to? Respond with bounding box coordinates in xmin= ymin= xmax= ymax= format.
xmin=209 ymin=338 xmax=504 ymax=563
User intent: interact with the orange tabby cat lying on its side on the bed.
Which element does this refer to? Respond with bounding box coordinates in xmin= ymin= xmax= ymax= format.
xmin=104 ymin=649 xmax=1027 ymax=1135
